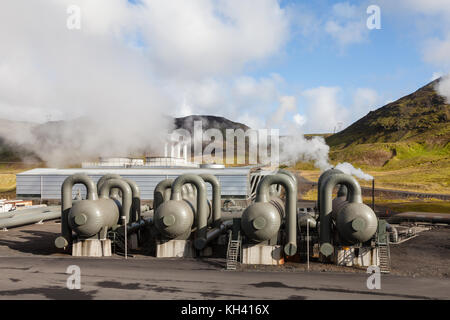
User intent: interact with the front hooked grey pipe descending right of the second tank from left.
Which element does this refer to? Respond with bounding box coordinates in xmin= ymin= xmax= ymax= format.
xmin=171 ymin=174 xmax=208 ymax=250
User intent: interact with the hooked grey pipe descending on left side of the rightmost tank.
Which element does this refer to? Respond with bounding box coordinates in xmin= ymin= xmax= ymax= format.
xmin=319 ymin=173 xmax=362 ymax=257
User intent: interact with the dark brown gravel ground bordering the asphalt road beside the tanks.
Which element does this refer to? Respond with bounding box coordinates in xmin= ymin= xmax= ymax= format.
xmin=0 ymin=221 xmax=450 ymax=278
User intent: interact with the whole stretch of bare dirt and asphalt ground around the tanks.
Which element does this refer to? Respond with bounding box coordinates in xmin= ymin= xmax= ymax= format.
xmin=0 ymin=221 xmax=450 ymax=300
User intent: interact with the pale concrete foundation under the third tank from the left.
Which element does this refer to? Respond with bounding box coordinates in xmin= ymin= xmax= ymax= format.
xmin=242 ymin=244 xmax=284 ymax=265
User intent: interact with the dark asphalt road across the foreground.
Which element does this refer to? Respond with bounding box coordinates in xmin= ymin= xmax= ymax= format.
xmin=0 ymin=256 xmax=450 ymax=300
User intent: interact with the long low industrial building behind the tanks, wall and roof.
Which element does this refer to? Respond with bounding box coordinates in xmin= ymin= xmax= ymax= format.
xmin=16 ymin=165 xmax=271 ymax=200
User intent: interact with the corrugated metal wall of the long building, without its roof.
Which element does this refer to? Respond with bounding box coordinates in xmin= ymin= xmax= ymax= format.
xmin=16 ymin=174 xmax=249 ymax=200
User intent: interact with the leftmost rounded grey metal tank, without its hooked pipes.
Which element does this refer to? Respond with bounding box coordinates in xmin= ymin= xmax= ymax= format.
xmin=68 ymin=199 xmax=119 ymax=238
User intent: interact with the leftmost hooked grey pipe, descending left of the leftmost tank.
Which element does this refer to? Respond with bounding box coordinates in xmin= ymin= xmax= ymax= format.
xmin=55 ymin=173 xmax=98 ymax=248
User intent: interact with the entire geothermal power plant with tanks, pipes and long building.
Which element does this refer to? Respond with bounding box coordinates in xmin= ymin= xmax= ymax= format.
xmin=4 ymin=156 xmax=398 ymax=272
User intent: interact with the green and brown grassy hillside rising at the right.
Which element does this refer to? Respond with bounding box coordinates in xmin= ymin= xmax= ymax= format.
xmin=306 ymin=79 xmax=450 ymax=194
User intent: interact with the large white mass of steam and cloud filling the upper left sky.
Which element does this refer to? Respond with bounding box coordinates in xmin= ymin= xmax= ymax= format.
xmin=0 ymin=0 xmax=289 ymax=166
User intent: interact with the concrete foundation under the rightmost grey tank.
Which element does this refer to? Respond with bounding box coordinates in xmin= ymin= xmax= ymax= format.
xmin=334 ymin=247 xmax=380 ymax=267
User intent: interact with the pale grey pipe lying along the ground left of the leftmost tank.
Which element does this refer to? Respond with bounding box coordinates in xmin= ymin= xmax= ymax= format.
xmin=0 ymin=206 xmax=61 ymax=228
